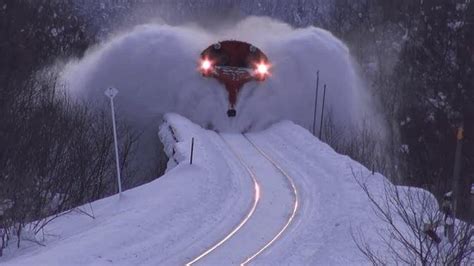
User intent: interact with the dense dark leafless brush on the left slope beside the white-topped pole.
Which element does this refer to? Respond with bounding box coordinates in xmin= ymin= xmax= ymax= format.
xmin=0 ymin=76 xmax=138 ymax=251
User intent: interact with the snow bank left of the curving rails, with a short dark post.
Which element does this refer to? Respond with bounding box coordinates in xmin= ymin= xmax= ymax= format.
xmin=0 ymin=115 xmax=251 ymax=266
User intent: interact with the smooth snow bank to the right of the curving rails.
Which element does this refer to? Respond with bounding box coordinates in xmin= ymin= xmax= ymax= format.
xmin=249 ymin=122 xmax=437 ymax=265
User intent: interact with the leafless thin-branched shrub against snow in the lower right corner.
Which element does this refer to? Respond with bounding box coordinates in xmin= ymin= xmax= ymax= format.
xmin=352 ymin=171 xmax=474 ymax=265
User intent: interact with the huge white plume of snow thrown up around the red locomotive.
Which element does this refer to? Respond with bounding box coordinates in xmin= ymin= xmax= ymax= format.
xmin=58 ymin=17 xmax=383 ymax=140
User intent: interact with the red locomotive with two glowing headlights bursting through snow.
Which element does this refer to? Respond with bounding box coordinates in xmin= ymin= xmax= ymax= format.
xmin=199 ymin=40 xmax=270 ymax=117
